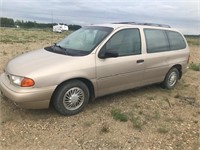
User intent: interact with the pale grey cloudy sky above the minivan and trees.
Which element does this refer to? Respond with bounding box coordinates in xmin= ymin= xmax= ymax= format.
xmin=0 ymin=0 xmax=200 ymax=34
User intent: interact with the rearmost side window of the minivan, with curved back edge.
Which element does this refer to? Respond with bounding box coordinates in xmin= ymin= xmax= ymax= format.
xmin=166 ymin=31 xmax=186 ymax=50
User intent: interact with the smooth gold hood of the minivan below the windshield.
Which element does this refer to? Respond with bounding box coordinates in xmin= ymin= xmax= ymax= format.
xmin=5 ymin=49 xmax=77 ymax=77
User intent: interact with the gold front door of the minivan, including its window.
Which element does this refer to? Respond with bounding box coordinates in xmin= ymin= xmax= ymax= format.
xmin=96 ymin=28 xmax=144 ymax=96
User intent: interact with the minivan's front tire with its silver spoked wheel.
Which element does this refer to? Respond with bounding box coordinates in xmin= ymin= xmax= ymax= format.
xmin=52 ymin=80 xmax=90 ymax=115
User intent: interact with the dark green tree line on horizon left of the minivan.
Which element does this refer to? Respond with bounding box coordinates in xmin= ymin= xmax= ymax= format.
xmin=0 ymin=17 xmax=81 ymax=30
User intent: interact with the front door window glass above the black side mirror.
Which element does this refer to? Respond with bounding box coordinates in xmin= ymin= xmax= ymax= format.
xmin=105 ymin=29 xmax=141 ymax=56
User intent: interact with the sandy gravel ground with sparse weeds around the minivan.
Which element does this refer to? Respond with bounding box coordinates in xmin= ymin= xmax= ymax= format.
xmin=0 ymin=30 xmax=200 ymax=150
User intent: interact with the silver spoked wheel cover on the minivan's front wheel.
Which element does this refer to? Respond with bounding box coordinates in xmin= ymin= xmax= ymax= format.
xmin=63 ymin=87 xmax=85 ymax=110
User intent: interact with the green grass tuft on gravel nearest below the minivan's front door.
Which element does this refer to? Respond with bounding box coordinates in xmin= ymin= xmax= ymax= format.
xmin=111 ymin=109 xmax=128 ymax=122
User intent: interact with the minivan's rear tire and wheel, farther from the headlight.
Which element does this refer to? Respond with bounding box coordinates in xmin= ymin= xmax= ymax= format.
xmin=163 ymin=68 xmax=180 ymax=89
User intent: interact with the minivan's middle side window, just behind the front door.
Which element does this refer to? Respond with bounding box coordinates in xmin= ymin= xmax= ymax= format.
xmin=144 ymin=29 xmax=170 ymax=53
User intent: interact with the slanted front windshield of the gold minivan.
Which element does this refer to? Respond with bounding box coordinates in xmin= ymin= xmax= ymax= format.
xmin=50 ymin=26 xmax=113 ymax=56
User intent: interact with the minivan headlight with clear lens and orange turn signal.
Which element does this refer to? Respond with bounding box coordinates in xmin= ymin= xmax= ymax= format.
xmin=9 ymin=75 xmax=35 ymax=87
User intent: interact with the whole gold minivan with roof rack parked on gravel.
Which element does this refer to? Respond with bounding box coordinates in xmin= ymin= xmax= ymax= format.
xmin=0 ymin=22 xmax=189 ymax=115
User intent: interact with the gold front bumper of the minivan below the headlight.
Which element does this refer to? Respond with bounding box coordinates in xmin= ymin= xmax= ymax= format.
xmin=0 ymin=73 xmax=56 ymax=109
